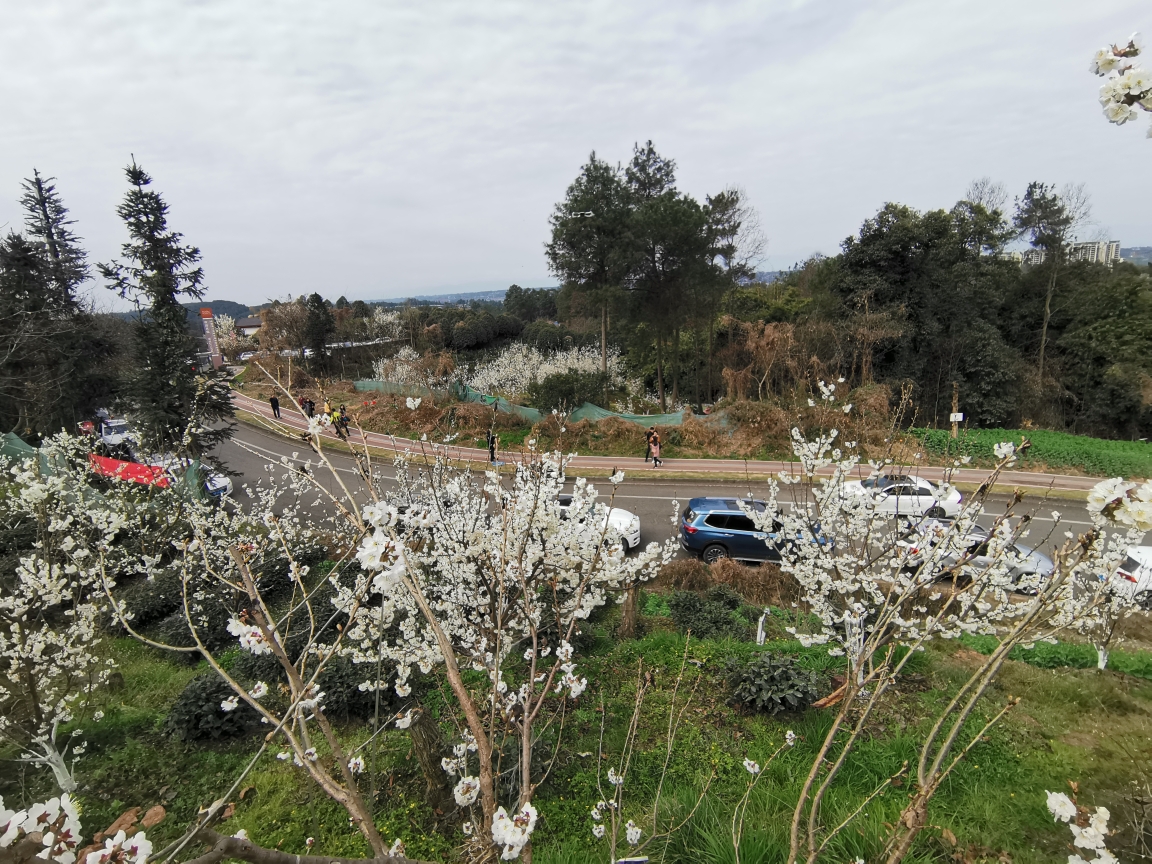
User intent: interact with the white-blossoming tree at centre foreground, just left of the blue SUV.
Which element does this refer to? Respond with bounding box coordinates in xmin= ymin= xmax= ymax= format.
xmin=336 ymin=453 xmax=674 ymax=861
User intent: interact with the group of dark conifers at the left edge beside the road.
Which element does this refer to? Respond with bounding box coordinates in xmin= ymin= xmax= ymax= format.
xmin=0 ymin=160 xmax=233 ymax=456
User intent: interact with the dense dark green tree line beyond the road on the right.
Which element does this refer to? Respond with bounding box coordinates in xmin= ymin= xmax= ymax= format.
xmin=546 ymin=142 xmax=1152 ymax=438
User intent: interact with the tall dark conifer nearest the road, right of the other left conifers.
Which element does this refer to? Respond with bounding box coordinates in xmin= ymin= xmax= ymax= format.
xmin=100 ymin=159 xmax=234 ymax=457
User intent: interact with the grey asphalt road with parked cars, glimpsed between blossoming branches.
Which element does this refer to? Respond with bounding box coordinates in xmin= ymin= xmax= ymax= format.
xmin=219 ymin=424 xmax=1091 ymax=562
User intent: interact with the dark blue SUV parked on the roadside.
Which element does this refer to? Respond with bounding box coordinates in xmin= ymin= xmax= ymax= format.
xmin=680 ymin=498 xmax=783 ymax=564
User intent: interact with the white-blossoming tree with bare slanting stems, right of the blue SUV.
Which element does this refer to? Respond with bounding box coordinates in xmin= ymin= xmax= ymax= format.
xmin=749 ymin=385 xmax=1144 ymax=864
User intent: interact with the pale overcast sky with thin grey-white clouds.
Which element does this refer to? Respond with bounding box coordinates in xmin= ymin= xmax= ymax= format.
xmin=0 ymin=0 xmax=1152 ymax=303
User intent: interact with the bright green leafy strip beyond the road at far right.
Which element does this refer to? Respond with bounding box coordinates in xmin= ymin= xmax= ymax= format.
xmin=911 ymin=429 xmax=1152 ymax=477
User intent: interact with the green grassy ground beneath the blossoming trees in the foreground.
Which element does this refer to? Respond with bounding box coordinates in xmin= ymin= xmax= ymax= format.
xmin=9 ymin=596 xmax=1152 ymax=864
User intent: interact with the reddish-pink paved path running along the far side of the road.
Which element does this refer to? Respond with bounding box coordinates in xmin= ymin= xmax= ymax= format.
xmin=233 ymin=392 xmax=1099 ymax=492
